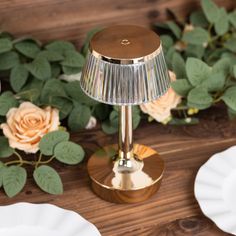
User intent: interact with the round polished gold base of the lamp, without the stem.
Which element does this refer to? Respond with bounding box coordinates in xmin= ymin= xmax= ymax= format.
xmin=88 ymin=144 xmax=164 ymax=203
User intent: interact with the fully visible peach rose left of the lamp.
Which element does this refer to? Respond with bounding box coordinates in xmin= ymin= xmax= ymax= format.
xmin=0 ymin=102 xmax=60 ymax=153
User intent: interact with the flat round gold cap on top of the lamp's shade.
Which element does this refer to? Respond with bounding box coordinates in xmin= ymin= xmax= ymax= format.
xmin=89 ymin=25 xmax=161 ymax=64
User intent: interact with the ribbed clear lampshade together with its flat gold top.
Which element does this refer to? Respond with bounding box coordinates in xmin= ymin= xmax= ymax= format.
xmin=81 ymin=25 xmax=170 ymax=105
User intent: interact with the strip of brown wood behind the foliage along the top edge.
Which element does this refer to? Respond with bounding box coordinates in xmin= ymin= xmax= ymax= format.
xmin=0 ymin=0 xmax=236 ymax=46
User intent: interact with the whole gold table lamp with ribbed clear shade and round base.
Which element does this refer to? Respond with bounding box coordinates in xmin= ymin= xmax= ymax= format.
xmin=81 ymin=25 xmax=170 ymax=203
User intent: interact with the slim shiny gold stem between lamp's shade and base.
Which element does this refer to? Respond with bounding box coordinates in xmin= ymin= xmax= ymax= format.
xmin=119 ymin=106 xmax=134 ymax=170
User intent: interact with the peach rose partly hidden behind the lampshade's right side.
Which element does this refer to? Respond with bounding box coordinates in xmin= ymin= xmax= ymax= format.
xmin=140 ymin=71 xmax=181 ymax=123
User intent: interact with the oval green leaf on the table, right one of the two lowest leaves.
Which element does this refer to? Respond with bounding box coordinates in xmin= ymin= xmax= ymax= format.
xmin=33 ymin=165 xmax=63 ymax=194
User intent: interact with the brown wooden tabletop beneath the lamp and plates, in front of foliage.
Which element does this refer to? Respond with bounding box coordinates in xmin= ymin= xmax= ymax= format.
xmin=0 ymin=109 xmax=236 ymax=236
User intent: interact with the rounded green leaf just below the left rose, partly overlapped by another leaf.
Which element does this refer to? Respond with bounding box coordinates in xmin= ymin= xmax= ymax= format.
xmin=39 ymin=130 xmax=70 ymax=156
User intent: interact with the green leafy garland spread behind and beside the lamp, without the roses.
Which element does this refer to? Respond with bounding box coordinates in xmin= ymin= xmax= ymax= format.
xmin=0 ymin=0 xmax=236 ymax=197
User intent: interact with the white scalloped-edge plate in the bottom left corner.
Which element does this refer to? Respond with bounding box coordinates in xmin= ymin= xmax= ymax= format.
xmin=0 ymin=203 xmax=101 ymax=236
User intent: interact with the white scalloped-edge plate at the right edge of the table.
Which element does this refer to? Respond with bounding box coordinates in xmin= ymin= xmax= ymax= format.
xmin=194 ymin=146 xmax=236 ymax=235
